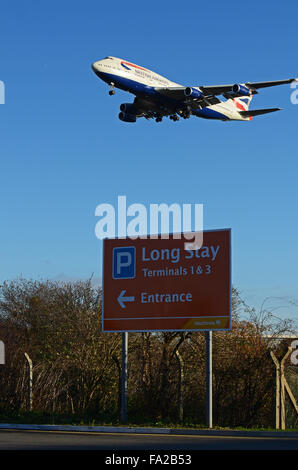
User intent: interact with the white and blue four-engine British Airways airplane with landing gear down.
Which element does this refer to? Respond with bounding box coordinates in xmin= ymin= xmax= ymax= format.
xmin=92 ymin=56 xmax=298 ymax=122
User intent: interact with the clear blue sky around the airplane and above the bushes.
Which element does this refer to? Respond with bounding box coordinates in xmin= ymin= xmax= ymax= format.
xmin=0 ymin=0 xmax=298 ymax=317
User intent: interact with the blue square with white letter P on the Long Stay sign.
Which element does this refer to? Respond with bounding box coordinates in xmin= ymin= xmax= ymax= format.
xmin=113 ymin=246 xmax=136 ymax=279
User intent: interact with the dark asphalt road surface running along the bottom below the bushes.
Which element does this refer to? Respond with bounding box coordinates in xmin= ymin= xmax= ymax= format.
xmin=0 ymin=429 xmax=298 ymax=452
